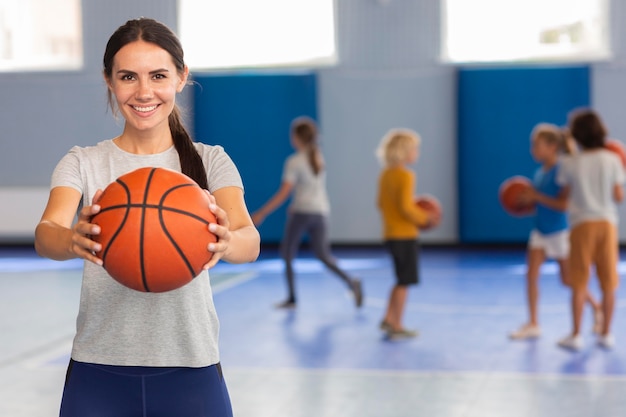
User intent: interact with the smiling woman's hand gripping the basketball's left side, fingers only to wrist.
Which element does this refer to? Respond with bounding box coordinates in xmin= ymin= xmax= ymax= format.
xmin=70 ymin=190 xmax=102 ymax=265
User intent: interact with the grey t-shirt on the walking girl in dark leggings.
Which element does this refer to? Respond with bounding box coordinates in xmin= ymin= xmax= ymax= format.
xmin=282 ymin=152 xmax=330 ymax=215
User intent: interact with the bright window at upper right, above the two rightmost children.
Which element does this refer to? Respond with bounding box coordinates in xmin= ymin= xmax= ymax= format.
xmin=441 ymin=0 xmax=611 ymax=62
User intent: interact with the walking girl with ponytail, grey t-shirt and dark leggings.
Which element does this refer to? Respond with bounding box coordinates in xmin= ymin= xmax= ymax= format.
xmin=252 ymin=117 xmax=363 ymax=308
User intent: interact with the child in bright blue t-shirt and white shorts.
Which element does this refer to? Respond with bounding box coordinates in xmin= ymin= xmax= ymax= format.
xmin=510 ymin=123 xmax=602 ymax=339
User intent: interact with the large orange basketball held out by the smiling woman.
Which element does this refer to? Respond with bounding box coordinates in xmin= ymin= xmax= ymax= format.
xmin=92 ymin=167 xmax=217 ymax=292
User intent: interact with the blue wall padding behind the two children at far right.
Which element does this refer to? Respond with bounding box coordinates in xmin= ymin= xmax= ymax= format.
xmin=458 ymin=66 xmax=590 ymax=243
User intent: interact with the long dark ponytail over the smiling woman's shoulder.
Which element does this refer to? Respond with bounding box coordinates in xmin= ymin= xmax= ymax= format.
xmin=168 ymin=106 xmax=209 ymax=189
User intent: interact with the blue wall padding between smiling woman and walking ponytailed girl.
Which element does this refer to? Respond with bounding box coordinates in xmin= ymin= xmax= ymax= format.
xmin=194 ymin=73 xmax=317 ymax=243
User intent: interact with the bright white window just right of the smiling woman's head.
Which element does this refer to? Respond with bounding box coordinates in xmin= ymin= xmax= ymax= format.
xmin=178 ymin=0 xmax=336 ymax=69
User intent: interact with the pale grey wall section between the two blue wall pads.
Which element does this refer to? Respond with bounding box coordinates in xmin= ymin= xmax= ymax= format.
xmin=319 ymin=0 xmax=458 ymax=242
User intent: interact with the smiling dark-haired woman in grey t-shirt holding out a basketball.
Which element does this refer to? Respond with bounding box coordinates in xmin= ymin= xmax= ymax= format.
xmin=35 ymin=18 xmax=260 ymax=417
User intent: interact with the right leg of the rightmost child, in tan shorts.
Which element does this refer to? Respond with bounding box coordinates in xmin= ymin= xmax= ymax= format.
xmin=594 ymin=222 xmax=619 ymax=335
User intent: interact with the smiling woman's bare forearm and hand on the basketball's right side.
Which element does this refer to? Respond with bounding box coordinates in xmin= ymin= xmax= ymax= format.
xmin=204 ymin=187 xmax=261 ymax=269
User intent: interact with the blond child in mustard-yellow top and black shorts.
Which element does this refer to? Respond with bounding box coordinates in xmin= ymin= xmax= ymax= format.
xmin=376 ymin=129 xmax=440 ymax=340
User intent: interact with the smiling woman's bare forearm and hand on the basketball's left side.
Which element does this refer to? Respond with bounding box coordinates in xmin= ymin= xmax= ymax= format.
xmin=35 ymin=187 xmax=102 ymax=265
